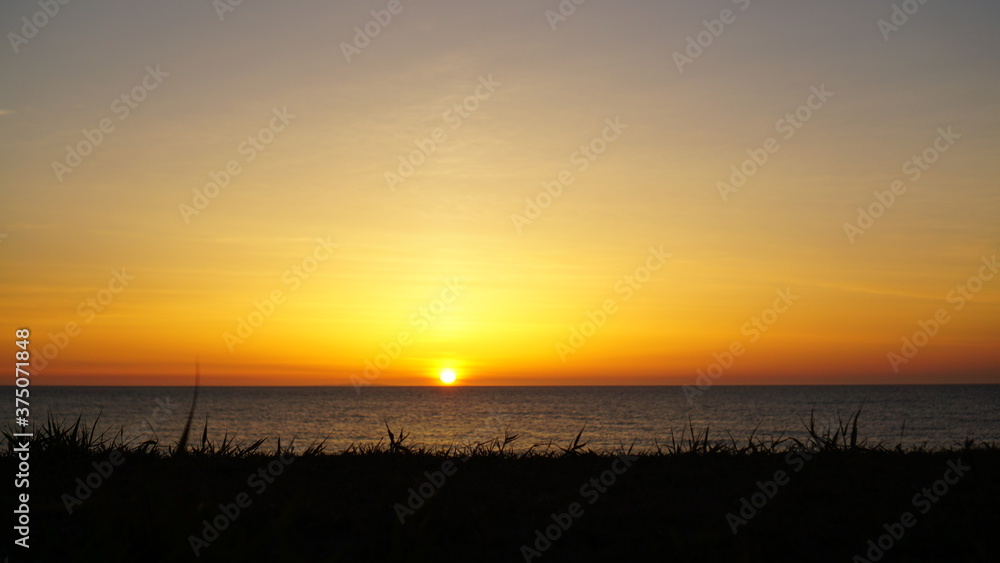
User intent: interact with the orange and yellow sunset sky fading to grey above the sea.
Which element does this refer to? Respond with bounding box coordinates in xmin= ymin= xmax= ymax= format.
xmin=0 ymin=0 xmax=1000 ymax=388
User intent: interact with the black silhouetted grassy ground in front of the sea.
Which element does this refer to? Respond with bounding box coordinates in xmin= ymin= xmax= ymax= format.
xmin=0 ymin=426 xmax=1000 ymax=562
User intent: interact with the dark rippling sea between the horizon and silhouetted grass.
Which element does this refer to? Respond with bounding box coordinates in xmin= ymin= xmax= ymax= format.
xmin=13 ymin=385 xmax=1000 ymax=451
